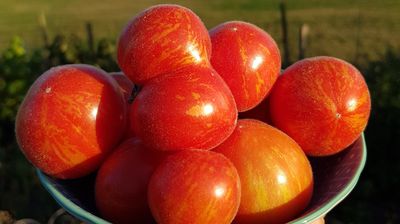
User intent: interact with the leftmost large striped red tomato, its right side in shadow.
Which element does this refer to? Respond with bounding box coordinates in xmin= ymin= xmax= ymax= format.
xmin=15 ymin=65 xmax=126 ymax=179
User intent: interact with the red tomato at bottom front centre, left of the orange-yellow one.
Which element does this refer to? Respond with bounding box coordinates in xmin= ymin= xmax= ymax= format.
xmin=148 ymin=150 xmax=240 ymax=224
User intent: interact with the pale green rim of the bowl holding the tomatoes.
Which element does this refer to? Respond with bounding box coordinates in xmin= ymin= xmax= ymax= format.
xmin=36 ymin=133 xmax=367 ymax=224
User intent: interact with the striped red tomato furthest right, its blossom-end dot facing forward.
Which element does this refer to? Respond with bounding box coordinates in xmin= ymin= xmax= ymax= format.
xmin=270 ymin=56 xmax=371 ymax=156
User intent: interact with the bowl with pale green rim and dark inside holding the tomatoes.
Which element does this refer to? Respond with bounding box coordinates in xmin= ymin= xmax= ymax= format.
xmin=37 ymin=134 xmax=367 ymax=224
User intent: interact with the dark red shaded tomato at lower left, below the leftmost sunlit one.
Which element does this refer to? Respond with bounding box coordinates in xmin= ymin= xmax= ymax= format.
xmin=95 ymin=138 xmax=164 ymax=223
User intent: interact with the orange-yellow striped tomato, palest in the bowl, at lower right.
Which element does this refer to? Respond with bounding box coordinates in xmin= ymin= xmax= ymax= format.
xmin=214 ymin=119 xmax=313 ymax=223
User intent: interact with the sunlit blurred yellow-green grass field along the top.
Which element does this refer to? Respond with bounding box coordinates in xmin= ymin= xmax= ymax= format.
xmin=0 ymin=0 xmax=400 ymax=61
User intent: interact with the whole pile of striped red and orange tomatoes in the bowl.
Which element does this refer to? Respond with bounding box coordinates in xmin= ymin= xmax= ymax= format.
xmin=16 ymin=5 xmax=371 ymax=224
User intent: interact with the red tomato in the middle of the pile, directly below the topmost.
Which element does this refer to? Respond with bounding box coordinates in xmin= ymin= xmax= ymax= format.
xmin=130 ymin=67 xmax=237 ymax=151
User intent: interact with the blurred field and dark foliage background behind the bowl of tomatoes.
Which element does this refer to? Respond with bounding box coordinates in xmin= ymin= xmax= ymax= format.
xmin=0 ymin=0 xmax=400 ymax=223
